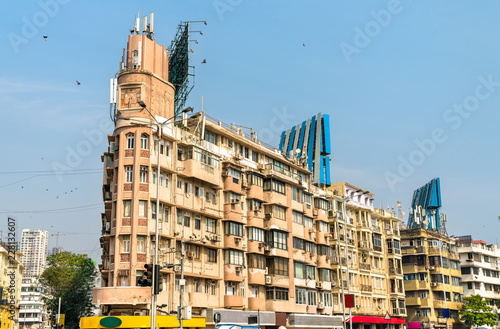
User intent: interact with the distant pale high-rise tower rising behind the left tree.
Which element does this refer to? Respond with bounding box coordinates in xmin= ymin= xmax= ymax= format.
xmin=21 ymin=229 xmax=49 ymax=276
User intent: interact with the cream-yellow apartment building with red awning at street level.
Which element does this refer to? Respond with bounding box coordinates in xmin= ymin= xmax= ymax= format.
xmin=329 ymin=182 xmax=406 ymax=328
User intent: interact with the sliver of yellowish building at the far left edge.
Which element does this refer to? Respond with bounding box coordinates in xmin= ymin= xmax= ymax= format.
xmin=0 ymin=242 xmax=24 ymax=329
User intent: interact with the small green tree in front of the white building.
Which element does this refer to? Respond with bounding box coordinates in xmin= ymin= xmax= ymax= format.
xmin=460 ymin=295 xmax=498 ymax=328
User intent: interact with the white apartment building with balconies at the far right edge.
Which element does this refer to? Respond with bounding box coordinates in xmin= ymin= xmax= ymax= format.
xmin=456 ymin=235 xmax=500 ymax=327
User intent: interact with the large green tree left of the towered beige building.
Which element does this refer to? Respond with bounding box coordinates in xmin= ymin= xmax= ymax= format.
xmin=39 ymin=251 xmax=97 ymax=329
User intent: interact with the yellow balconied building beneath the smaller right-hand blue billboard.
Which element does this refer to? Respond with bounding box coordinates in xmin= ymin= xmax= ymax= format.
xmin=401 ymin=227 xmax=463 ymax=328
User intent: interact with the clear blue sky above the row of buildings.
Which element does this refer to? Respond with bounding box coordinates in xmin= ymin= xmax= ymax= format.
xmin=0 ymin=0 xmax=500 ymax=259
